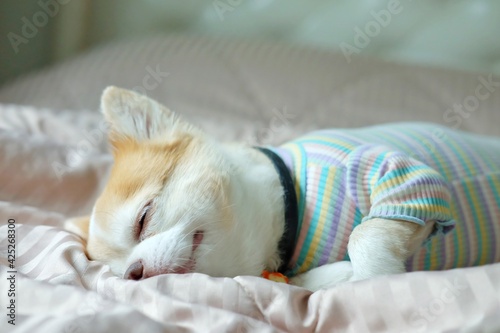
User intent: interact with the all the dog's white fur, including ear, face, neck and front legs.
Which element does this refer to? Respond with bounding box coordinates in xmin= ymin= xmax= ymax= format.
xmin=67 ymin=87 xmax=430 ymax=290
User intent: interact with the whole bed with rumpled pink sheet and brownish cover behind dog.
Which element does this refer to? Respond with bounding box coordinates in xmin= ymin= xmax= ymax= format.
xmin=0 ymin=35 xmax=500 ymax=333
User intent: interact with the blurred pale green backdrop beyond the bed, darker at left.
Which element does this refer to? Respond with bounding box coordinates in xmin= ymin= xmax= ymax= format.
xmin=0 ymin=0 xmax=500 ymax=83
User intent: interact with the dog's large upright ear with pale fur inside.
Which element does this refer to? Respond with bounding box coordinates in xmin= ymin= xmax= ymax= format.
xmin=101 ymin=86 xmax=188 ymax=143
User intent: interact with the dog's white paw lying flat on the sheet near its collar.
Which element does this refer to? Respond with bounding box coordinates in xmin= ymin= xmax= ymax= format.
xmin=290 ymin=261 xmax=353 ymax=291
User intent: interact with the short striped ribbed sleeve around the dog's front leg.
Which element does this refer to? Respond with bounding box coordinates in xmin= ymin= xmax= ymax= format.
xmin=347 ymin=145 xmax=454 ymax=232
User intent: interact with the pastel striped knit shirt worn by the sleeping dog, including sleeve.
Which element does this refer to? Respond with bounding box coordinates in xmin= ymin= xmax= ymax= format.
xmin=271 ymin=123 xmax=500 ymax=275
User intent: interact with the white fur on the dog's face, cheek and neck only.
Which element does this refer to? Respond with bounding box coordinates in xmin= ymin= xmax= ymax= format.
xmin=90 ymin=141 xmax=283 ymax=276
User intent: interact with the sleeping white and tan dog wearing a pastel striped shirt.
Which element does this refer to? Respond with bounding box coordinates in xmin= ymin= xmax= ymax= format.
xmin=66 ymin=87 xmax=500 ymax=290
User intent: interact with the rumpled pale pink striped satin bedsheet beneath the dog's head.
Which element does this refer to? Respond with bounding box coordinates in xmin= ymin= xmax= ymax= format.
xmin=0 ymin=105 xmax=500 ymax=332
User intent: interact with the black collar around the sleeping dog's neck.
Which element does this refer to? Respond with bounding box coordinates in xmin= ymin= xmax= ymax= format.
xmin=256 ymin=147 xmax=299 ymax=274
